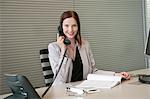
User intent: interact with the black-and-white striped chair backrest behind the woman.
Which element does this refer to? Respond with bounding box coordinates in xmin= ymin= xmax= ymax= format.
xmin=40 ymin=49 xmax=54 ymax=86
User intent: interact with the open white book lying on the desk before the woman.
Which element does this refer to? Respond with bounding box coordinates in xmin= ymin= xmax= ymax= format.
xmin=75 ymin=74 xmax=122 ymax=92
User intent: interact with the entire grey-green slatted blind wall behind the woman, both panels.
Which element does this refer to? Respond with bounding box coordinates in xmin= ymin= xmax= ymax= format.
xmin=0 ymin=0 xmax=145 ymax=94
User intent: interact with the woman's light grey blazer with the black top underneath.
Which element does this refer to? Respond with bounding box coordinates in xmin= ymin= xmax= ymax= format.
xmin=48 ymin=39 xmax=114 ymax=84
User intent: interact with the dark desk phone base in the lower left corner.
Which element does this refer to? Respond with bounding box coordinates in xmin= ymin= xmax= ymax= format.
xmin=4 ymin=74 xmax=41 ymax=99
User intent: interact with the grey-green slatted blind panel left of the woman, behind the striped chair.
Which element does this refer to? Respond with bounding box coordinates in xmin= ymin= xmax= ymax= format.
xmin=0 ymin=0 xmax=73 ymax=94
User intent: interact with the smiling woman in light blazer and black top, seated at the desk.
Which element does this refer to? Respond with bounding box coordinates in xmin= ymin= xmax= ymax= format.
xmin=48 ymin=11 xmax=130 ymax=84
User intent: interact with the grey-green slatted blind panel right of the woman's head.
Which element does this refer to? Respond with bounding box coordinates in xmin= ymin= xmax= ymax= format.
xmin=74 ymin=0 xmax=146 ymax=71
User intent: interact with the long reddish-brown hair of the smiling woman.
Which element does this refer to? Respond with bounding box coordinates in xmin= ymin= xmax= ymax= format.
xmin=60 ymin=11 xmax=82 ymax=46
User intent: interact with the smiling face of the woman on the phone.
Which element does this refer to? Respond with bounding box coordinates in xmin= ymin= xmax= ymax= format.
xmin=62 ymin=17 xmax=78 ymax=39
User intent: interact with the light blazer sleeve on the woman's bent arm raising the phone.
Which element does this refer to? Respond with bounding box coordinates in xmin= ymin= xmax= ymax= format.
xmin=48 ymin=42 xmax=71 ymax=83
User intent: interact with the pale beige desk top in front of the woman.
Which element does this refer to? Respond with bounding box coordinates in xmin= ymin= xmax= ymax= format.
xmin=1 ymin=68 xmax=150 ymax=99
